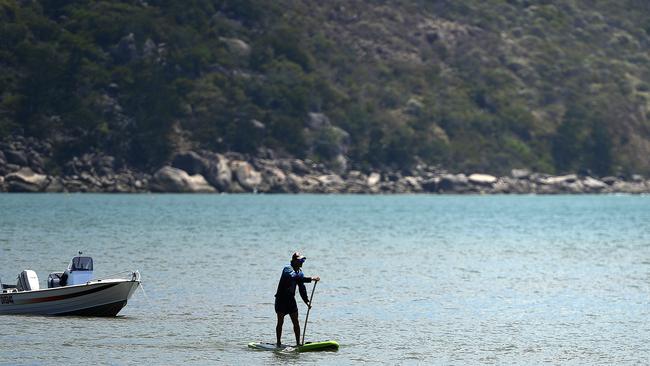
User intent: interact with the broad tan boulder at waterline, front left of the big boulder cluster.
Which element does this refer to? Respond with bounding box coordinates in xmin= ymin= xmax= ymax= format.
xmin=151 ymin=166 xmax=216 ymax=193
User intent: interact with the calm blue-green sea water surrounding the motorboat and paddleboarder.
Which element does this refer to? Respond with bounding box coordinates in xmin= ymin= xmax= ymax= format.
xmin=0 ymin=194 xmax=650 ymax=365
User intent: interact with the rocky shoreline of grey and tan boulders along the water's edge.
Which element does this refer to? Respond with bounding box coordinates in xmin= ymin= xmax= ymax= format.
xmin=0 ymin=137 xmax=650 ymax=195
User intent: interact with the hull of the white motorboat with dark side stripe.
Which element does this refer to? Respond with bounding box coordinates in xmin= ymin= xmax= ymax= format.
xmin=0 ymin=280 xmax=140 ymax=316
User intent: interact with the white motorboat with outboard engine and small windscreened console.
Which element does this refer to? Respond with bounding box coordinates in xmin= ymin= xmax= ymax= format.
xmin=0 ymin=252 xmax=140 ymax=316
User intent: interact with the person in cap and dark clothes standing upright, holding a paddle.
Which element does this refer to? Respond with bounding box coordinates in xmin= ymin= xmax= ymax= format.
xmin=275 ymin=252 xmax=320 ymax=347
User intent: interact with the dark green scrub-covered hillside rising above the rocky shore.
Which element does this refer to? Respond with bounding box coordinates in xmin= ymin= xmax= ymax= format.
xmin=0 ymin=0 xmax=650 ymax=175
